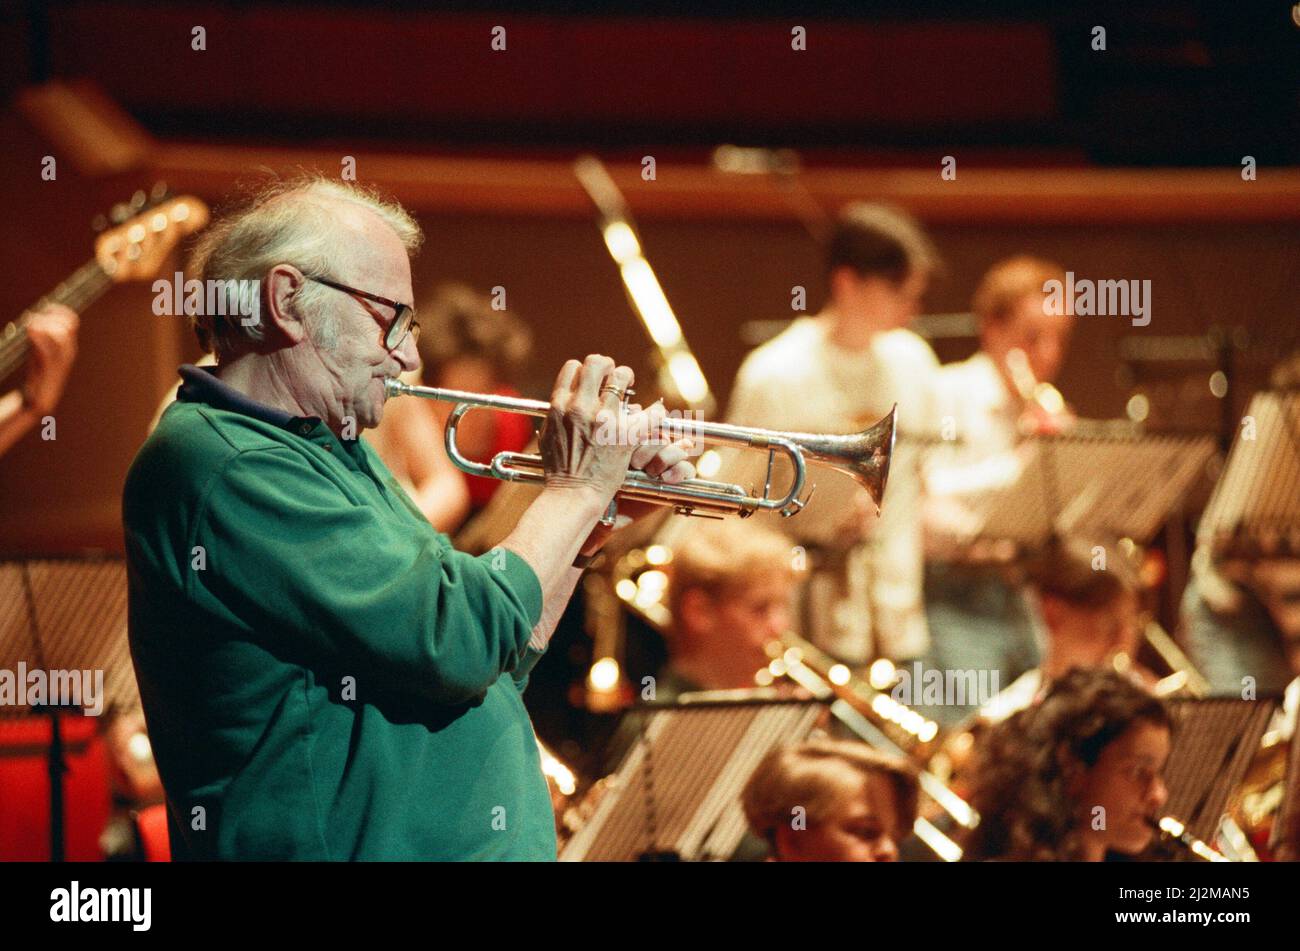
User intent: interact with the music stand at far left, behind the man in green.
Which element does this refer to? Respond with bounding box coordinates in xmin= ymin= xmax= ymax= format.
xmin=0 ymin=556 xmax=140 ymax=861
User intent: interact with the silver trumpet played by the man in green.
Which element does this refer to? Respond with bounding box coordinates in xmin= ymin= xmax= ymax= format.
xmin=384 ymin=377 xmax=897 ymax=524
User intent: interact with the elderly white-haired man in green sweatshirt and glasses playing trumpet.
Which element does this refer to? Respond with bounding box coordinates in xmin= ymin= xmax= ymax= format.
xmin=124 ymin=179 xmax=693 ymax=860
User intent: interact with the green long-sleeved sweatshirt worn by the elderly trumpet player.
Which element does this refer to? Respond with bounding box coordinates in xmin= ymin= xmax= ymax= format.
xmin=122 ymin=366 xmax=555 ymax=860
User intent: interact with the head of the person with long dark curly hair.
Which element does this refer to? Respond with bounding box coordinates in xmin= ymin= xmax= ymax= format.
xmin=965 ymin=668 xmax=1171 ymax=861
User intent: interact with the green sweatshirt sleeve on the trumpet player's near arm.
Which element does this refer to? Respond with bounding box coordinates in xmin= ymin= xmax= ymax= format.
xmin=186 ymin=448 xmax=542 ymax=704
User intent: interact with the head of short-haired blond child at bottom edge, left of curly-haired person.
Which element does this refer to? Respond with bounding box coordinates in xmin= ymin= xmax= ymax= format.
xmin=741 ymin=739 xmax=918 ymax=861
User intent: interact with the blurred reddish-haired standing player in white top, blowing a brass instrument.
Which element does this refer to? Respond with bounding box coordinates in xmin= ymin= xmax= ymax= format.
xmin=926 ymin=257 xmax=1071 ymax=724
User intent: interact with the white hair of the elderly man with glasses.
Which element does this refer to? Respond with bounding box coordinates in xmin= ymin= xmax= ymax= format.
xmin=190 ymin=175 xmax=424 ymax=359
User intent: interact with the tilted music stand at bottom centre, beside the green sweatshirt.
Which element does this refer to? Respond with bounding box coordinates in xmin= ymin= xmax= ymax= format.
xmin=559 ymin=695 xmax=826 ymax=861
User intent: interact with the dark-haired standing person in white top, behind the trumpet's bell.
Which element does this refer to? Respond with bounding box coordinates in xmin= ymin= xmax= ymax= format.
xmin=729 ymin=203 xmax=939 ymax=663
